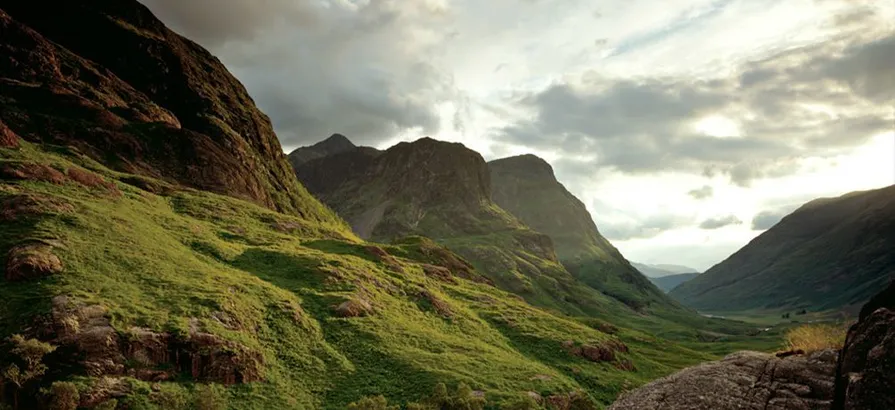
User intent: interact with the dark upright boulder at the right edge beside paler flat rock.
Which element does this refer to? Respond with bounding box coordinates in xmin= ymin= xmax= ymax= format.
xmin=833 ymin=282 xmax=895 ymax=410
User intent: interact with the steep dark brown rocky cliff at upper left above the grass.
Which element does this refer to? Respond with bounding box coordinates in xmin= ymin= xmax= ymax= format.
xmin=0 ymin=0 xmax=332 ymax=220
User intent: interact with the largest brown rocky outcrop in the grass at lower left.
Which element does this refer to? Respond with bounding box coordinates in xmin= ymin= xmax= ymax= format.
xmin=51 ymin=296 xmax=263 ymax=384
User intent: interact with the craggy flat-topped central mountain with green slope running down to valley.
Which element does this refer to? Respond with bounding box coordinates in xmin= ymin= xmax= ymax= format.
xmin=296 ymin=138 xmax=658 ymax=314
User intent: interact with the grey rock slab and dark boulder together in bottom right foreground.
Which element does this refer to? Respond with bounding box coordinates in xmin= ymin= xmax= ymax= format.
xmin=610 ymin=282 xmax=895 ymax=410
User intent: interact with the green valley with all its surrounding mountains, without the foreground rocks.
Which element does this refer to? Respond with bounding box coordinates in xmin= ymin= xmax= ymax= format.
xmin=0 ymin=0 xmax=895 ymax=410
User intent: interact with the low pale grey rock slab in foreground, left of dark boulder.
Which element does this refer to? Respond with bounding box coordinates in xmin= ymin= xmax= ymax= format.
xmin=610 ymin=350 xmax=837 ymax=410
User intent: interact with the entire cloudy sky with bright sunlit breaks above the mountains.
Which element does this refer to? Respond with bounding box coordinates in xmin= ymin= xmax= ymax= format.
xmin=143 ymin=0 xmax=895 ymax=269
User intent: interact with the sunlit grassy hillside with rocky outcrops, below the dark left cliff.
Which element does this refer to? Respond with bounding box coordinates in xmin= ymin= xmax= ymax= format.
xmin=0 ymin=142 xmax=784 ymax=409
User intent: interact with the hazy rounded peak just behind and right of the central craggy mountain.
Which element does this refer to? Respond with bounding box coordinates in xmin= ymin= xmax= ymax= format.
xmin=488 ymin=155 xmax=677 ymax=308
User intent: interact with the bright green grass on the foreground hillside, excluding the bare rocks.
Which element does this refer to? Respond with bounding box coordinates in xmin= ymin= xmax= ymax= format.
xmin=0 ymin=143 xmax=779 ymax=409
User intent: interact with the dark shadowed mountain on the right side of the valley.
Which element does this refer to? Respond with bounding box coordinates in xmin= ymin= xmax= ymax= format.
xmin=671 ymin=186 xmax=895 ymax=312
